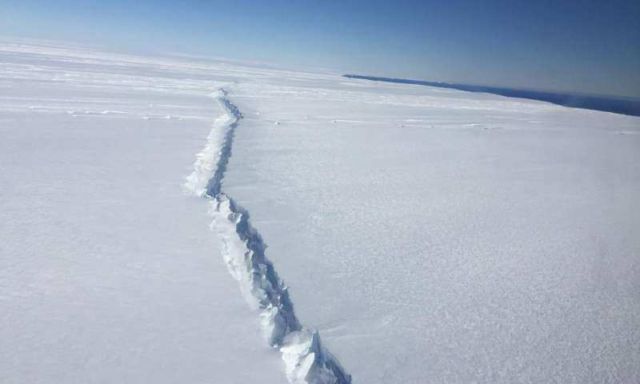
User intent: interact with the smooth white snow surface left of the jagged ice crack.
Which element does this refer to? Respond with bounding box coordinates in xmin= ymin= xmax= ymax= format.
xmin=0 ymin=44 xmax=286 ymax=384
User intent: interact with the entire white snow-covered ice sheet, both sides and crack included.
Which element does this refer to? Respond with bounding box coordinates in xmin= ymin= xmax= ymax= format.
xmin=0 ymin=42 xmax=640 ymax=384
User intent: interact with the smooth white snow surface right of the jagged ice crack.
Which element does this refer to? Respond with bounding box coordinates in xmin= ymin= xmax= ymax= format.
xmin=224 ymin=79 xmax=640 ymax=383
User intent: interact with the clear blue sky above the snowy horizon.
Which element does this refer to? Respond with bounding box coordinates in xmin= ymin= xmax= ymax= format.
xmin=0 ymin=0 xmax=640 ymax=97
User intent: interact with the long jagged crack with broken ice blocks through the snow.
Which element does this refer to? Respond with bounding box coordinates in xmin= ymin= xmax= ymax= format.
xmin=185 ymin=89 xmax=351 ymax=384
